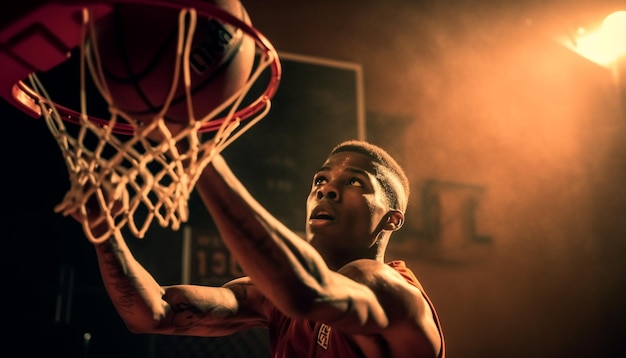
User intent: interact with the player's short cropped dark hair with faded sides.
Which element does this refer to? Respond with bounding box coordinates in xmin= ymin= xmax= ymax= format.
xmin=328 ymin=140 xmax=410 ymax=213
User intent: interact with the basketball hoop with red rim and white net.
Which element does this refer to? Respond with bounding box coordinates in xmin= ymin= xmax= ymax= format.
xmin=0 ymin=0 xmax=281 ymax=243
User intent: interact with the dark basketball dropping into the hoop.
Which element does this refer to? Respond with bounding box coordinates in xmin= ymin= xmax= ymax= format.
xmin=91 ymin=0 xmax=255 ymax=122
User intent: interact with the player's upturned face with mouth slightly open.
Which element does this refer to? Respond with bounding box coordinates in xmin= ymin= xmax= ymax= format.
xmin=306 ymin=152 xmax=389 ymax=261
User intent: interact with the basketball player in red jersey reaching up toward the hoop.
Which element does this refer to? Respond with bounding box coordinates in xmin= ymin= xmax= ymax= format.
xmin=74 ymin=141 xmax=445 ymax=358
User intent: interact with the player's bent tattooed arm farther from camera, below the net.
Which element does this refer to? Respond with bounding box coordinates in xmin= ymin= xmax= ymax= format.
xmin=90 ymin=234 xmax=265 ymax=336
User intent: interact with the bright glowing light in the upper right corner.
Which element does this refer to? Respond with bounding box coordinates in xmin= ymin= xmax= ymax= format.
xmin=570 ymin=11 xmax=626 ymax=67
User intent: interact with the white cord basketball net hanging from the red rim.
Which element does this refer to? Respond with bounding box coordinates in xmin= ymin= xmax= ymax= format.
xmin=28 ymin=8 xmax=280 ymax=243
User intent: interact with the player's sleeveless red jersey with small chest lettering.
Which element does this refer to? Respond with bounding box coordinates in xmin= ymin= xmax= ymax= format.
xmin=268 ymin=260 xmax=445 ymax=358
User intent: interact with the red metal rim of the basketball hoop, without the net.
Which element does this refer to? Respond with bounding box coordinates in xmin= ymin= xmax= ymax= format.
xmin=2 ymin=0 xmax=282 ymax=135
